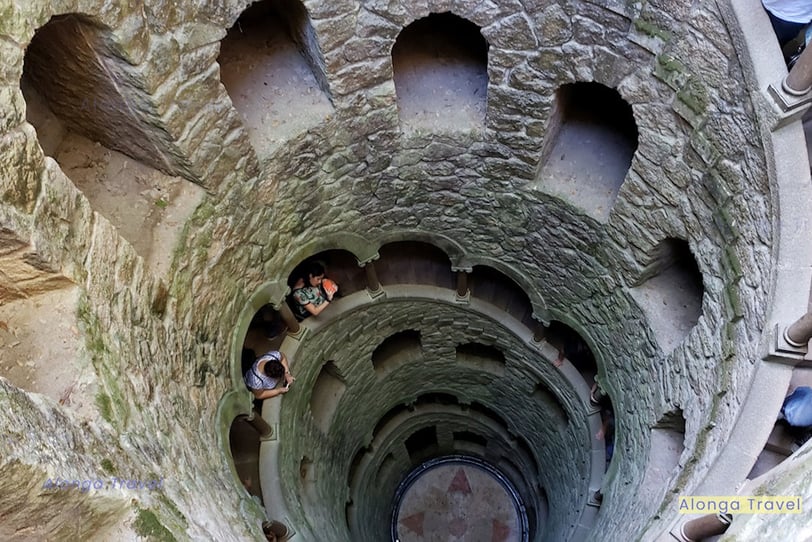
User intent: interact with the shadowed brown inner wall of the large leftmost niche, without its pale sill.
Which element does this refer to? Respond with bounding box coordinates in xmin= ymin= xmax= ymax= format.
xmin=21 ymin=14 xmax=173 ymax=173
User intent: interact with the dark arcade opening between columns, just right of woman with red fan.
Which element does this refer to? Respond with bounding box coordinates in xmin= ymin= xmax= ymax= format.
xmin=375 ymin=241 xmax=454 ymax=288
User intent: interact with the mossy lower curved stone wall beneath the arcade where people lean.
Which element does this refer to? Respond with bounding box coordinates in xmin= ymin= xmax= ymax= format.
xmin=279 ymin=296 xmax=588 ymax=540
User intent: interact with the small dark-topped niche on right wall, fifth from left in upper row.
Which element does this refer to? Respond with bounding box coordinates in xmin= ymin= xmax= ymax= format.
xmin=632 ymin=238 xmax=705 ymax=353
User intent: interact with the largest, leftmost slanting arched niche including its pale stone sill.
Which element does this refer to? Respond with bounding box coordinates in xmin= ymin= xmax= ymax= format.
xmin=20 ymin=14 xmax=204 ymax=275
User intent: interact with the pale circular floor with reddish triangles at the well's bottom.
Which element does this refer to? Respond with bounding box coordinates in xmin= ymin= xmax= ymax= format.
xmin=393 ymin=459 xmax=524 ymax=542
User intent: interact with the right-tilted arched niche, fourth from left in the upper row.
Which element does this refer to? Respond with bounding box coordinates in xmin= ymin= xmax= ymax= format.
xmin=537 ymin=82 xmax=638 ymax=221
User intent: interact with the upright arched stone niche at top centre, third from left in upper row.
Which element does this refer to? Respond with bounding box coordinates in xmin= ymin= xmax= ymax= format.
xmin=392 ymin=12 xmax=488 ymax=133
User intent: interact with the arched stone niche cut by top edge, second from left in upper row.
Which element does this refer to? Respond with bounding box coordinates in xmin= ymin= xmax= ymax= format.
xmin=218 ymin=0 xmax=333 ymax=160
